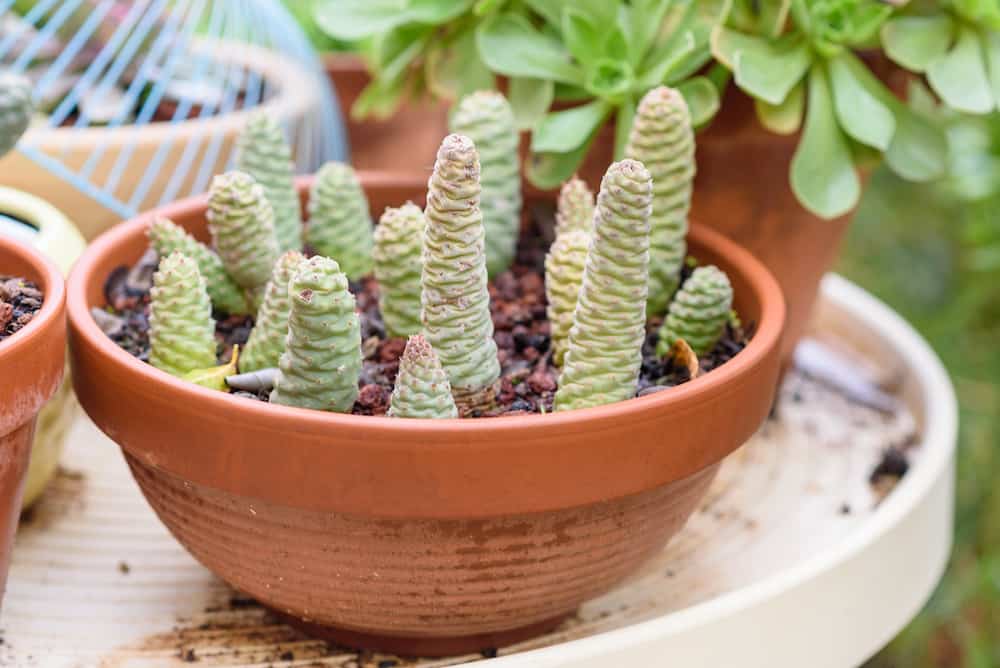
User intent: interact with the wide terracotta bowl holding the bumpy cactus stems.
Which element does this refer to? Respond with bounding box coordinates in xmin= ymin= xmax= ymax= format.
xmin=69 ymin=173 xmax=784 ymax=655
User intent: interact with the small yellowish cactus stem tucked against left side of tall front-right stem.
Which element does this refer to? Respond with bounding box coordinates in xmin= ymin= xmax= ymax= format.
xmin=545 ymin=227 xmax=590 ymax=366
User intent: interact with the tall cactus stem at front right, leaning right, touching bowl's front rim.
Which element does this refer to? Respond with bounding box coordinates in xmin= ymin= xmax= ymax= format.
xmin=555 ymin=160 xmax=652 ymax=410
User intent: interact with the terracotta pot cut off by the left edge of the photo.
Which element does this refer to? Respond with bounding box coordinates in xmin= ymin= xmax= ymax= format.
xmin=0 ymin=236 xmax=66 ymax=600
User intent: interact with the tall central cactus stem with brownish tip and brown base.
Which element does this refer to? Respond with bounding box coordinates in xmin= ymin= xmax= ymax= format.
xmin=420 ymin=134 xmax=500 ymax=414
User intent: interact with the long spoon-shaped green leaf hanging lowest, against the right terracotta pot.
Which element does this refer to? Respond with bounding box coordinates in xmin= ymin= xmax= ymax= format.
xmin=791 ymin=66 xmax=861 ymax=219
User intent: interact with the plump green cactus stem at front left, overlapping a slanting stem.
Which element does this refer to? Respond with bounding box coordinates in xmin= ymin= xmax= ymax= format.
xmin=271 ymin=256 xmax=361 ymax=413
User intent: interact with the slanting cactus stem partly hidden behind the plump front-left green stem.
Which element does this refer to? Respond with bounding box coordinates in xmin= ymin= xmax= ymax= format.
xmin=240 ymin=251 xmax=306 ymax=372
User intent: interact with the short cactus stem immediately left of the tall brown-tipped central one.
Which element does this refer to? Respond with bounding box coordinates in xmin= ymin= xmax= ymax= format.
xmin=372 ymin=202 xmax=427 ymax=337
